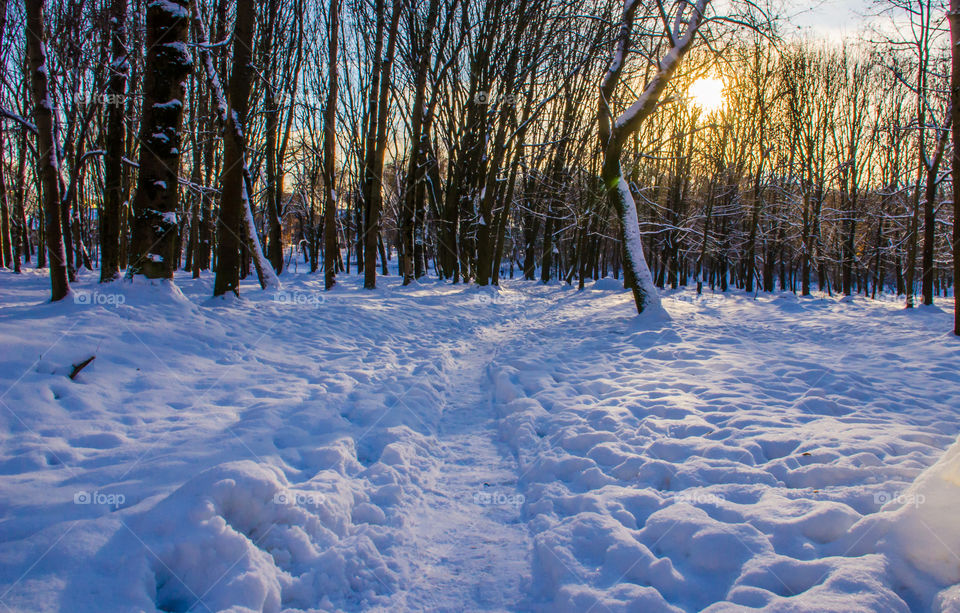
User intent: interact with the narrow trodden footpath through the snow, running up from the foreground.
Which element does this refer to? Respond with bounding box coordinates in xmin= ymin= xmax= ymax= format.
xmin=392 ymin=332 xmax=530 ymax=611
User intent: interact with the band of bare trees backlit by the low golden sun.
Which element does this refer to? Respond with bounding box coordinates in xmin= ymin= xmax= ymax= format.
xmin=0 ymin=0 xmax=957 ymax=334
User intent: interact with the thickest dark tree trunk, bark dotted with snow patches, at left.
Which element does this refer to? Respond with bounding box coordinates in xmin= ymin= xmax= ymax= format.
xmin=127 ymin=0 xmax=192 ymax=279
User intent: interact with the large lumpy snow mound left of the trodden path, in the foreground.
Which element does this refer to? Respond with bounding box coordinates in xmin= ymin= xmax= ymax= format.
xmin=130 ymin=461 xmax=397 ymax=613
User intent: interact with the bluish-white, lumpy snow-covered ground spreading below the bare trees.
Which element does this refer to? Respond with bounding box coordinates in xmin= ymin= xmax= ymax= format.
xmin=0 ymin=271 xmax=960 ymax=613
